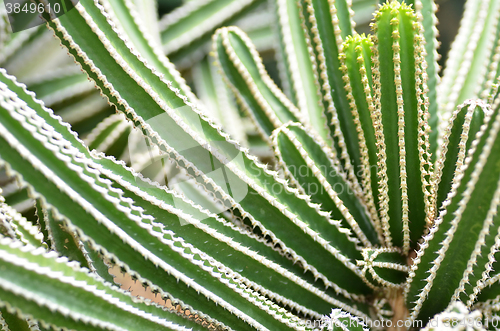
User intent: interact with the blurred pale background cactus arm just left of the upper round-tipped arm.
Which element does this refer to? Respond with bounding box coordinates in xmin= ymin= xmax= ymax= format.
xmin=191 ymin=56 xmax=248 ymax=146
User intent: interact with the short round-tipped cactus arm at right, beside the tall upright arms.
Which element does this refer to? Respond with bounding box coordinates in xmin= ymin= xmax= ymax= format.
xmin=432 ymin=100 xmax=491 ymax=211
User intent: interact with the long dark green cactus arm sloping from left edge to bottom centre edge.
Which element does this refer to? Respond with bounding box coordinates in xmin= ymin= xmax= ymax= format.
xmin=0 ymin=78 xmax=316 ymax=329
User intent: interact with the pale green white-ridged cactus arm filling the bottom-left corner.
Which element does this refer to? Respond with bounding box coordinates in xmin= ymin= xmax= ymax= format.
xmin=0 ymin=238 xmax=202 ymax=330
